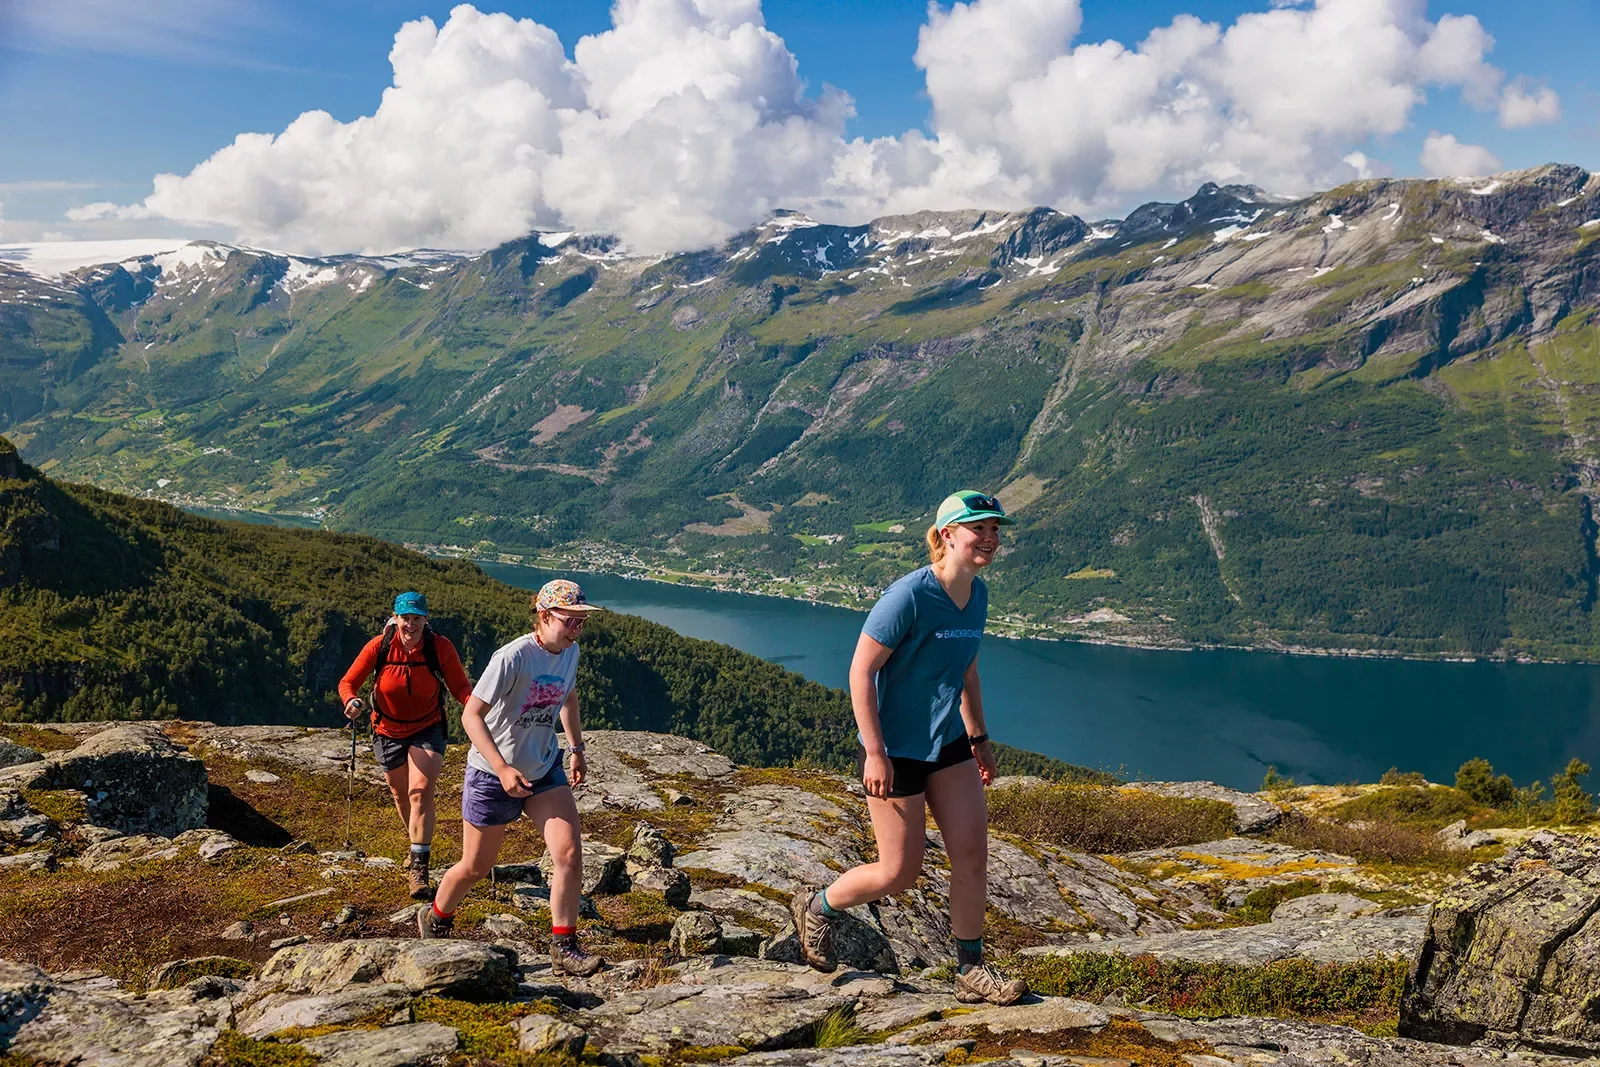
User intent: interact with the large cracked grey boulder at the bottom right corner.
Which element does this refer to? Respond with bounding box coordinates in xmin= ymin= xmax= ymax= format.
xmin=1400 ymin=833 xmax=1600 ymax=1056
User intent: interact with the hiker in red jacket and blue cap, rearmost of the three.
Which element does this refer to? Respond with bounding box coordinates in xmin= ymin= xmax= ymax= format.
xmin=339 ymin=592 xmax=472 ymax=901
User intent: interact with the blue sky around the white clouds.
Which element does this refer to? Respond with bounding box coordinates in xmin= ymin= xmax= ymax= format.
xmin=0 ymin=0 xmax=1600 ymax=251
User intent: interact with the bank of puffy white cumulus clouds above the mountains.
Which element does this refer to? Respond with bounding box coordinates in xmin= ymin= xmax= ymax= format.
xmin=90 ymin=0 xmax=1560 ymax=251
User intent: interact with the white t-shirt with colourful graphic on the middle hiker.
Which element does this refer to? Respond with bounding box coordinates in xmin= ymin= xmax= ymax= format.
xmin=467 ymin=633 xmax=578 ymax=782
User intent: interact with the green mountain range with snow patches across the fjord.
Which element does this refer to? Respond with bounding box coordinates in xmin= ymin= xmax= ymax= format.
xmin=0 ymin=165 xmax=1600 ymax=659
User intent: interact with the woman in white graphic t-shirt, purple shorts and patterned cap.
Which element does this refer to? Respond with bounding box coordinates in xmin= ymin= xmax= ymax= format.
xmin=416 ymin=579 xmax=602 ymax=976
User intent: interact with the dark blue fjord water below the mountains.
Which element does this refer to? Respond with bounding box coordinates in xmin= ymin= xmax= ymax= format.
xmin=483 ymin=565 xmax=1600 ymax=790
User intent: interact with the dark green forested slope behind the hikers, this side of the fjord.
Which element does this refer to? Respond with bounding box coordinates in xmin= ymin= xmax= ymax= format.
xmin=0 ymin=438 xmax=1091 ymax=776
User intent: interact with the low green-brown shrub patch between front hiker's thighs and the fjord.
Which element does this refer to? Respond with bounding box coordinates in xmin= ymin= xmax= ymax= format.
xmin=989 ymin=785 xmax=1234 ymax=853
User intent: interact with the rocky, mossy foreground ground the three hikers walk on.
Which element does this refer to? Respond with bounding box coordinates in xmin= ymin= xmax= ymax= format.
xmin=0 ymin=723 xmax=1574 ymax=1067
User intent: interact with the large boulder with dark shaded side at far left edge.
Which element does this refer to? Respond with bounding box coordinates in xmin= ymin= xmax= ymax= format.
xmin=8 ymin=723 xmax=206 ymax=837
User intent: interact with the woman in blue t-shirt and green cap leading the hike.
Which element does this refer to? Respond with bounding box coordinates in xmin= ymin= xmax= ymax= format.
xmin=789 ymin=490 xmax=1027 ymax=1005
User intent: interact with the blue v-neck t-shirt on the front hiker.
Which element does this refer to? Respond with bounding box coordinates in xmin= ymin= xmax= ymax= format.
xmin=861 ymin=566 xmax=989 ymax=763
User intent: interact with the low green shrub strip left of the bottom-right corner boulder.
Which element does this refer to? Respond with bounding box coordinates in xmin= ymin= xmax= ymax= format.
xmin=1005 ymin=952 xmax=1406 ymax=1032
